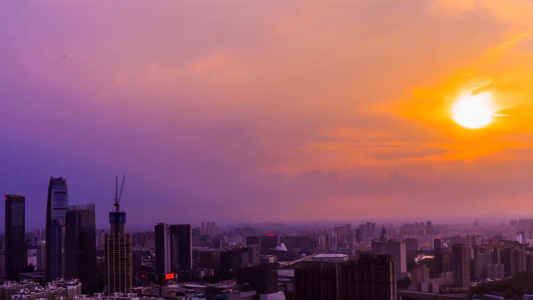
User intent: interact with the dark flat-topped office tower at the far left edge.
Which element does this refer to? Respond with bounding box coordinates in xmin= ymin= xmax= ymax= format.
xmin=5 ymin=195 xmax=27 ymax=280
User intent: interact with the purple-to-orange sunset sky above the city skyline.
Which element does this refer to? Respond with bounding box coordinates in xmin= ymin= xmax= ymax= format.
xmin=0 ymin=0 xmax=533 ymax=228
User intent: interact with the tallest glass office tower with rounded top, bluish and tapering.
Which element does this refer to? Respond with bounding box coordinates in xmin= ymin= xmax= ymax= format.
xmin=46 ymin=177 xmax=68 ymax=281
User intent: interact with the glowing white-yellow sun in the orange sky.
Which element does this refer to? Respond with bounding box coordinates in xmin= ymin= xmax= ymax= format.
xmin=451 ymin=91 xmax=496 ymax=129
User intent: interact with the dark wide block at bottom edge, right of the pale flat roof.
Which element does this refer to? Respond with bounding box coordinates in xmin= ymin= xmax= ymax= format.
xmin=340 ymin=253 xmax=397 ymax=300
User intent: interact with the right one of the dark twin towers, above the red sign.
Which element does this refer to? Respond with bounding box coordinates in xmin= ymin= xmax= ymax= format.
xmin=170 ymin=222 xmax=192 ymax=273
